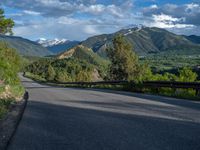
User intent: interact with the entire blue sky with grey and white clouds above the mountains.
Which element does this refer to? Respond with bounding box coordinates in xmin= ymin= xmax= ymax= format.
xmin=0 ymin=0 xmax=200 ymax=40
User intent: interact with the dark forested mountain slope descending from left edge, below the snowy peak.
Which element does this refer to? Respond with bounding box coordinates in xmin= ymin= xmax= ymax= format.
xmin=0 ymin=35 xmax=52 ymax=56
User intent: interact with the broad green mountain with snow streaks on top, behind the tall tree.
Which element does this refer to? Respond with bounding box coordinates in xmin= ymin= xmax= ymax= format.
xmin=81 ymin=26 xmax=200 ymax=57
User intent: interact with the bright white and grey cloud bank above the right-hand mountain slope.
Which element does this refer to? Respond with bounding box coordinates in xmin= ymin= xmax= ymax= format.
xmin=142 ymin=3 xmax=200 ymax=34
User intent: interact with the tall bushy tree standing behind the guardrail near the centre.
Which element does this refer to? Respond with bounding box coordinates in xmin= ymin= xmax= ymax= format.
xmin=107 ymin=35 xmax=139 ymax=80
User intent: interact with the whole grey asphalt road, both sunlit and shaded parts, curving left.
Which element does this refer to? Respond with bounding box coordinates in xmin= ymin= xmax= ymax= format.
xmin=8 ymin=77 xmax=200 ymax=150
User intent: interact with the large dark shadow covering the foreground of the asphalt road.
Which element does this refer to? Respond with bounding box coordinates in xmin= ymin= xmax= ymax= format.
xmin=8 ymin=101 xmax=200 ymax=150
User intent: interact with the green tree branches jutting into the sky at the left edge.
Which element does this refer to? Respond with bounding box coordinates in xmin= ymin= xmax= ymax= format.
xmin=0 ymin=9 xmax=15 ymax=35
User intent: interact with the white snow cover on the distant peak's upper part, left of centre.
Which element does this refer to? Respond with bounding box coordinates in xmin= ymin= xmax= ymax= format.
xmin=36 ymin=38 xmax=69 ymax=47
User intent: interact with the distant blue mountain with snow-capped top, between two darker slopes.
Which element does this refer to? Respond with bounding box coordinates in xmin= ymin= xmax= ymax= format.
xmin=36 ymin=38 xmax=80 ymax=54
